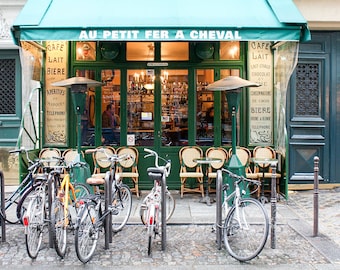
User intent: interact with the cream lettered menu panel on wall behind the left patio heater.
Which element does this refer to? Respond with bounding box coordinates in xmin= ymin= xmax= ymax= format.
xmin=45 ymin=41 xmax=68 ymax=146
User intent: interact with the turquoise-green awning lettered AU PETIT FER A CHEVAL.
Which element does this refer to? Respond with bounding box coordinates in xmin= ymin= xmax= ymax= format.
xmin=12 ymin=0 xmax=310 ymax=44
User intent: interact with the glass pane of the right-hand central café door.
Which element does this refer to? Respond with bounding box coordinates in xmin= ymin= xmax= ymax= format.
xmin=161 ymin=70 xmax=188 ymax=146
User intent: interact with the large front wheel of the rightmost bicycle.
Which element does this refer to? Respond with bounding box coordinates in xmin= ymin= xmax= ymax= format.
xmin=223 ymin=198 xmax=269 ymax=261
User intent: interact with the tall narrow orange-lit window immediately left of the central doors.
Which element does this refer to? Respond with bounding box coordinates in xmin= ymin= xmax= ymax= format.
xmin=101 ymin=69 xmax=120 ymax=145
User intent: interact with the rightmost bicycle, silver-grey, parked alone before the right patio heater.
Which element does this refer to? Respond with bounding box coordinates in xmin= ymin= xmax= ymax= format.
xmin=222 ymin=168 xmax=269 ymax=261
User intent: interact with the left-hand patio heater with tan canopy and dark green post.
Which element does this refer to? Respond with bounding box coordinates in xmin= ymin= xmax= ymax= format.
xmin=52 ymin=77 xmax=103 ymax=161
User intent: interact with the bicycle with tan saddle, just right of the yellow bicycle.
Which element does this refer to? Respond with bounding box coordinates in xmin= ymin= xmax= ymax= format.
xmin=75 ymin=148 xmax=132 ymax=263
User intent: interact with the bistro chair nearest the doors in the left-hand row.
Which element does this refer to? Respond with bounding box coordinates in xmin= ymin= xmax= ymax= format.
xmin=116 ymin=146 xmax=139 ymax=198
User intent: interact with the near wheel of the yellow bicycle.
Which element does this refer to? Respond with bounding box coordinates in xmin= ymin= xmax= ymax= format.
xmin=51 ymin=198 xmax=67 ymax=258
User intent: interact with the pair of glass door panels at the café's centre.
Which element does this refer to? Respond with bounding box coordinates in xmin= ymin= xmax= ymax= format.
xmin=127 ymin=69 xmax=188 ymax=147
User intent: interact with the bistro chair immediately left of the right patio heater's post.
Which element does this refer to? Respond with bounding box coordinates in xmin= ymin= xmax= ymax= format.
xmin=205 ymin=147 xmax=229 ymax=192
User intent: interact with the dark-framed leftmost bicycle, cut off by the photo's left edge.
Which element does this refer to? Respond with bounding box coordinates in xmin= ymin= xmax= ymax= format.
xmin=0 ymin=148 xmax=47 ymax=224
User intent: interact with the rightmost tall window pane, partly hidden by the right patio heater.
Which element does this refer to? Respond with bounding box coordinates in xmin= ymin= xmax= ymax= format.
xmin=220 ymin=69 xmax=240 ymax=145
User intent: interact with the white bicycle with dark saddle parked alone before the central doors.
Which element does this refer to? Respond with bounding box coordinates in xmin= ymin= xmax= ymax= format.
xmin=140 ymin=148 xmax=176 ymax=256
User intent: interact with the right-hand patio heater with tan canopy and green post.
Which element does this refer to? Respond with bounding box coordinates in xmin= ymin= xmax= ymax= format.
xmin=206 ymin=76 xmax=260 ymax=176
